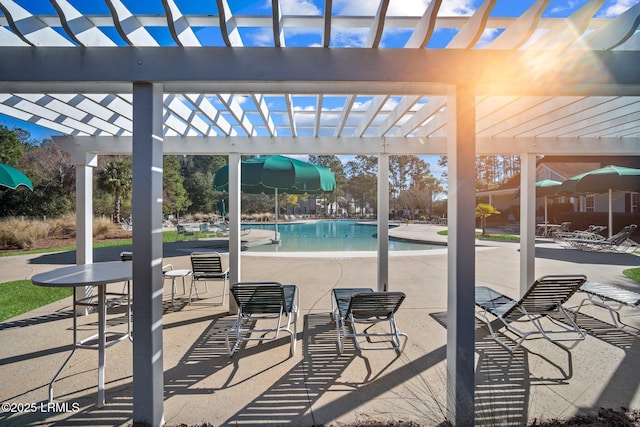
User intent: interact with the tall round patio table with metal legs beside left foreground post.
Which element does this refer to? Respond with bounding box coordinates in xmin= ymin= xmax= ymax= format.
xmin=31 ymin=261 xmax=133 ymax=407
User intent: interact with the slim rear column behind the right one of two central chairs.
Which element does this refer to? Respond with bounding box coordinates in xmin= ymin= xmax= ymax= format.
xmin=378 ymin=153 xmax=389 ymax=291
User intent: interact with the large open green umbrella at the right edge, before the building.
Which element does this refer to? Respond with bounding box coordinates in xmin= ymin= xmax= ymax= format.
xmin=559 ymin=165 xmax=640 ymax=237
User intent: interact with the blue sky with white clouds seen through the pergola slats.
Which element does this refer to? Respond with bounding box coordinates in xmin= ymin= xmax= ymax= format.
xmin=0 ymin=0 xmax=640 ymax=176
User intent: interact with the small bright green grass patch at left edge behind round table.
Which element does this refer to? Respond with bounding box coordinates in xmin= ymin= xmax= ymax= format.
xmin=0 ymin=280 xmax=73 ymax=322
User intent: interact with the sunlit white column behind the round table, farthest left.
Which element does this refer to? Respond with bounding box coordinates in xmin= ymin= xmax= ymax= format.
xmin=71 ymin=153 xmax=98 ymax=316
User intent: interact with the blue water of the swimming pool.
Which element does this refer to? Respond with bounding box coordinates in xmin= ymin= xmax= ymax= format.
xmin=242 ymin=220 xmax=442 ymax=252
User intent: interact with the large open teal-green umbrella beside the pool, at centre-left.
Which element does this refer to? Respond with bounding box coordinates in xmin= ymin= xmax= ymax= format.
xmin=213 ymin=155 xmax=336 ymax=241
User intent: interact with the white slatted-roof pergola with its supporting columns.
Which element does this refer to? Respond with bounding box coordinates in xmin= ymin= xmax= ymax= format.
xmin=0 ymin=0 xmax=640 ymax=425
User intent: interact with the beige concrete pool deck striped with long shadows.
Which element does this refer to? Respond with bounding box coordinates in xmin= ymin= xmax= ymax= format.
xmin=0 ymin=224 xmax=640 ymax=426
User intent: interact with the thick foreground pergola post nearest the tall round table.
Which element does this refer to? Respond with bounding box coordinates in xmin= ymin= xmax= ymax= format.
xmin=132 ymin=83 xmax=164 ymax=426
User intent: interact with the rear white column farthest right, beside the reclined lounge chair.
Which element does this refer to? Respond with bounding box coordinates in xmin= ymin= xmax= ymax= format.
xmin=520 ymin=153 xmax=536 ymax=296
